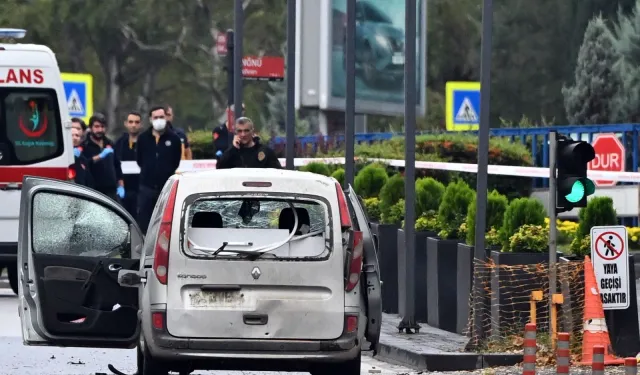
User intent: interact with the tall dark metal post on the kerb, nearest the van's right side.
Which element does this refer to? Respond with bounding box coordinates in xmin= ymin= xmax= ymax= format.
xmin=398 ymin=0 xmax=420 ymax=333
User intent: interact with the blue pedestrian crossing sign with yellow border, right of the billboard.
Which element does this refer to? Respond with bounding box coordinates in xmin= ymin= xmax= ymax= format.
xmin=446 ymin=82 xmax=480 ymax=132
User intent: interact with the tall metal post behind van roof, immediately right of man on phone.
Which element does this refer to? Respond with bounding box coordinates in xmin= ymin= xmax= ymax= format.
xmin=285 ymin=0 xmax=298 ymax=170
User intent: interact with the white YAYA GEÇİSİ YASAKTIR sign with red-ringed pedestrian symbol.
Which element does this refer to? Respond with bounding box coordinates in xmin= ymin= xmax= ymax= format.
xmin=591 ymin=225 xmax=630 ymax=310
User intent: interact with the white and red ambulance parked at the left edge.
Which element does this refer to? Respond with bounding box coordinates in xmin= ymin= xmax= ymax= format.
xmin=0 ymin=28 xmax=75 ymax=293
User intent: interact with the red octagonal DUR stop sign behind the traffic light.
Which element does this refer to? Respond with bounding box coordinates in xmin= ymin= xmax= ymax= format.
xmin=589 ymin=134 xmax=626 ymax=187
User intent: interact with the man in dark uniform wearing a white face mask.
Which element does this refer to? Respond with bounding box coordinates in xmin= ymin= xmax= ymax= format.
xmin=136 ymin=106 xmax=182 ymax=233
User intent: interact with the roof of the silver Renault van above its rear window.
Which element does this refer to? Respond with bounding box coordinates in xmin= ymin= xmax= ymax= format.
xmin=175 ymin=168 xmax=336 ymax=186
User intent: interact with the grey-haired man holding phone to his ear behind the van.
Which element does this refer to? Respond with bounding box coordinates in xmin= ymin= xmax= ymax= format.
xmin=217 ymin=117 xmax=282 ymax=169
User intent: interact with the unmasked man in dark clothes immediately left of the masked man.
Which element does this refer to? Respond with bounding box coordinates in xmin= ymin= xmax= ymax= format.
xmin=115 ymin=111 xmax=142 ymax=218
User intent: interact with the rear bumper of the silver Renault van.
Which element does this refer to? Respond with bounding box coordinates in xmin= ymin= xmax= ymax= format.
xmin=145 ymin=330 xmax=360 ymax=362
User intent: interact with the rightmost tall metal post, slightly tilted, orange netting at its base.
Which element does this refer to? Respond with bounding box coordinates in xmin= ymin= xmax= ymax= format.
xmin=470 ymin=0 xmax=493 ymax=344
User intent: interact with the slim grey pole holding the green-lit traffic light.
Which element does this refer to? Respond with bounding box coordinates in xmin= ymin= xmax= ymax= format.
xmin=549 ymin=131 xmax=558 ymax=324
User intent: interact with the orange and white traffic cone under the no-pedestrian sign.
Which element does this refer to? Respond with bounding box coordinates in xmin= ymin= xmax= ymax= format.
xmin=580 ymin=256 xmax=624 ymax=365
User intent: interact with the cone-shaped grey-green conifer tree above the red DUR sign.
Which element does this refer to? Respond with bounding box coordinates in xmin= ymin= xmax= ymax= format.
xmin=562 ymin=16 xmax=621 ymax=125
